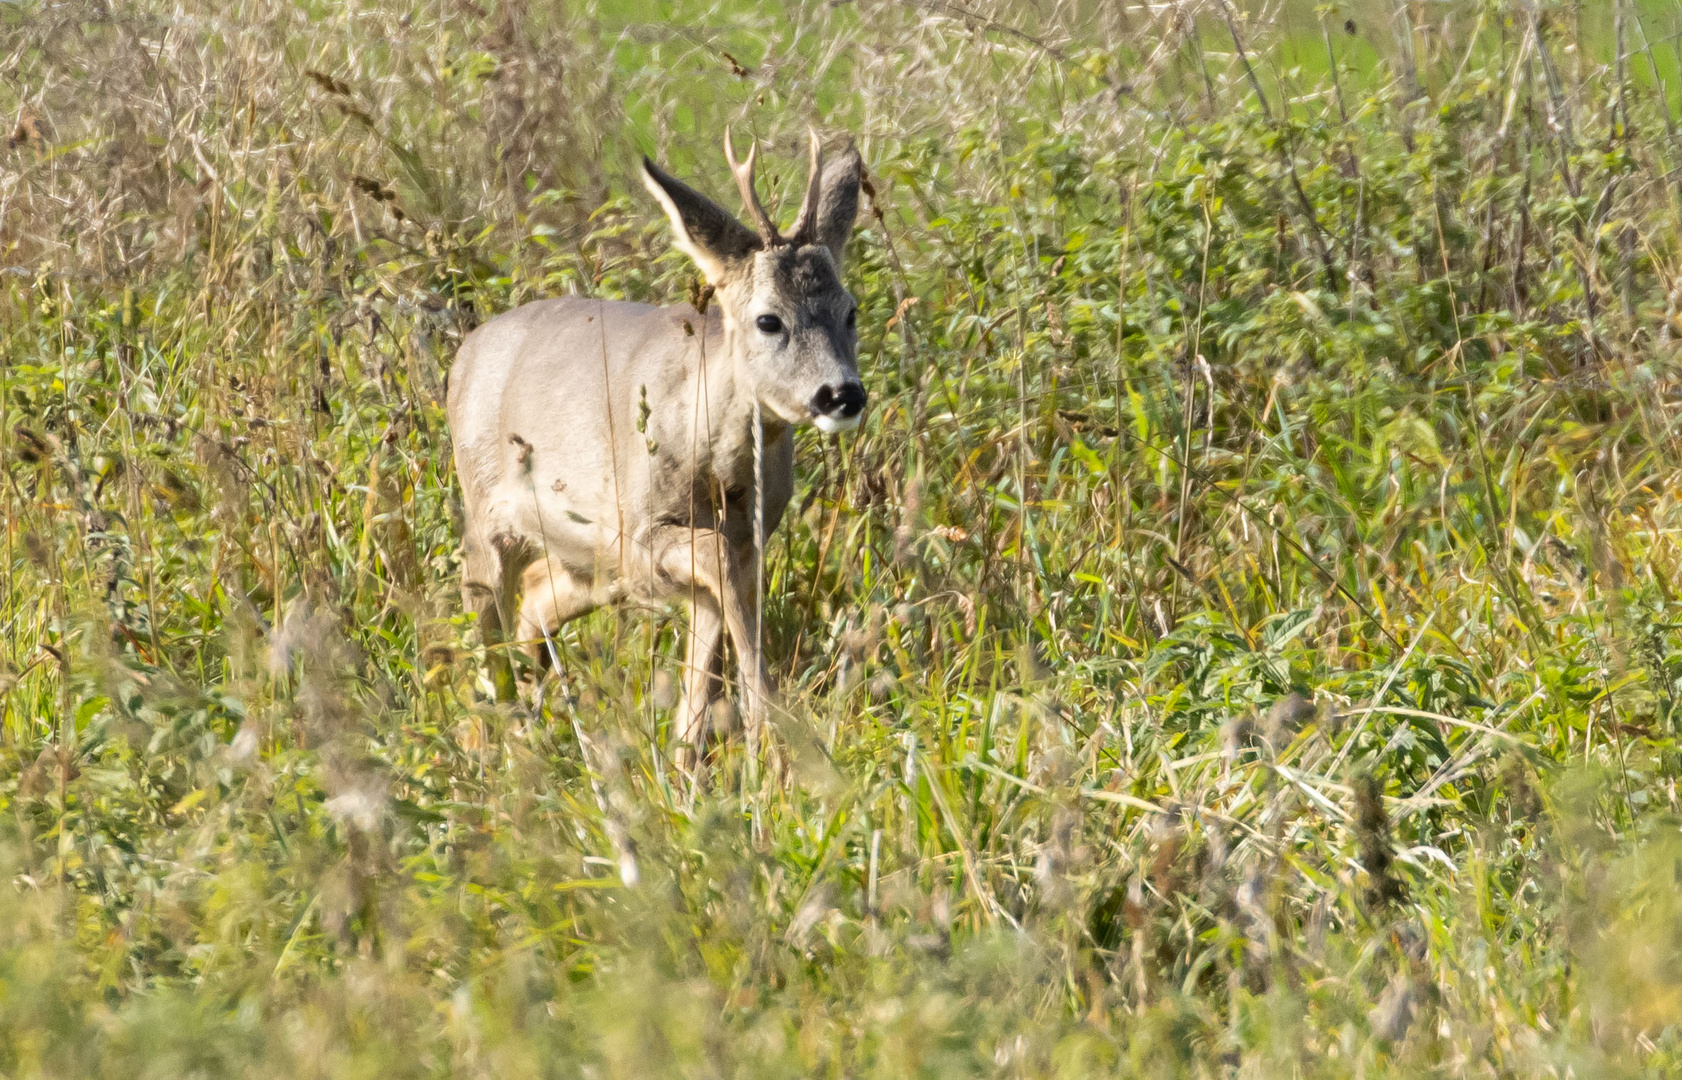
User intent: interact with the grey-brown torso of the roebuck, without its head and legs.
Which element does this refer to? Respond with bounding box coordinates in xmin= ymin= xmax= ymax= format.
xmin=449 ymin=298 xmax=794 ymax=588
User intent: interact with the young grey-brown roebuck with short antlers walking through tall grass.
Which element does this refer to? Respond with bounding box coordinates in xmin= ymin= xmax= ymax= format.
xmin=449 ymin=133 xmax=865 ymax=760
